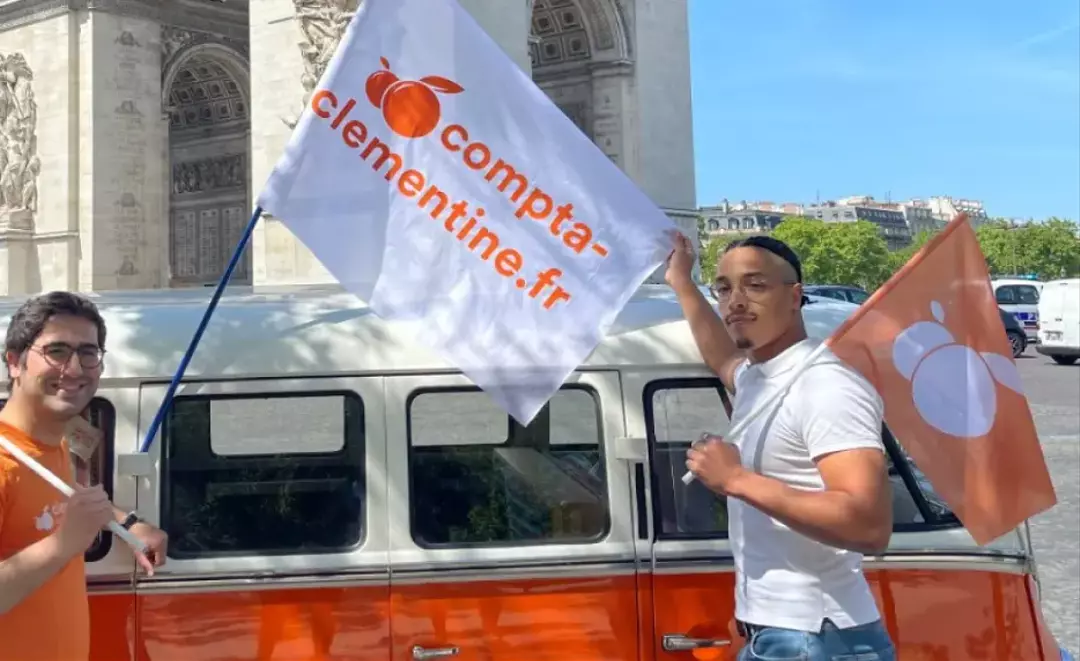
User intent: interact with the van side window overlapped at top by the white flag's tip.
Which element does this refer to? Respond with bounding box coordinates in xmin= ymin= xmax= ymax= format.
xmin=407 ymin=387 xmax=609 ymax=548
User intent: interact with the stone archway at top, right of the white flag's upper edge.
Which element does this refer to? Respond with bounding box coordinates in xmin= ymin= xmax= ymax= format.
xmin=529 ymin=0 xmax=633 ymax=167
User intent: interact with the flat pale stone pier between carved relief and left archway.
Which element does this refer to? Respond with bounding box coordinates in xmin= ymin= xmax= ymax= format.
xmin=78 ymin=10 xmax=167 ymax=291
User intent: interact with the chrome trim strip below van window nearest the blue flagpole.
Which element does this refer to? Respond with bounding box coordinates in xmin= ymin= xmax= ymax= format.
xmin=135 ymin=571 xmax=390 ymax=595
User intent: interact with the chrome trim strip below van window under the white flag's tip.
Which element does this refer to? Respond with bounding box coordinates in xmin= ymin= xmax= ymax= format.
xmin=390 ymin=561 xmax=644 ymax=585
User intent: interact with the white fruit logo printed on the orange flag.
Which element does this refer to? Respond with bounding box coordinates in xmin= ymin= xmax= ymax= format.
xmin=892 ymin=300 xmax=1024 ymax=439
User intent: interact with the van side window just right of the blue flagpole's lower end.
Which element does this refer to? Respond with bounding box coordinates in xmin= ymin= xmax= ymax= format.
xmin=161 ymin=392 xmax=365 ymax=558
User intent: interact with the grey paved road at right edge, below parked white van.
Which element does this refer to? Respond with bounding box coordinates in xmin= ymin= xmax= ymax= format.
xmin=1017 ymin=348 xmax=1080 ymax=656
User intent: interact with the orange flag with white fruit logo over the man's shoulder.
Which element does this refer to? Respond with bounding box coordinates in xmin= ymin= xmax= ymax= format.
xmin=828 ymin=214 xmax=1057 ymax=544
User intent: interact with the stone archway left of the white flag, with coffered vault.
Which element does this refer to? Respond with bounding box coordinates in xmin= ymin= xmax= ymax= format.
xmin=162 ymin=43 xmax=252 ymax=286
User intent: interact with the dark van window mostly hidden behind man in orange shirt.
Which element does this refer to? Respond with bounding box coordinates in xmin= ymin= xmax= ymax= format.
xmin=0 ymin=396 xmax=117 ymax=563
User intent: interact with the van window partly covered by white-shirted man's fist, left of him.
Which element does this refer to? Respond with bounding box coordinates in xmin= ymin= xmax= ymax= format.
xmin=645 ymin=379 xmax=729 ymax=539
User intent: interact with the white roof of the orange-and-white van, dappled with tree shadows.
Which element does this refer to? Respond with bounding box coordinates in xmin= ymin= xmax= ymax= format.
xmin=0 ymin=285 xmax=856 ymax=382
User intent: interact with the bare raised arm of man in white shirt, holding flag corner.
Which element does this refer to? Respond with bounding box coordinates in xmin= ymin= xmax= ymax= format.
xmin=664 ymin=233 xmax=744 ymax=392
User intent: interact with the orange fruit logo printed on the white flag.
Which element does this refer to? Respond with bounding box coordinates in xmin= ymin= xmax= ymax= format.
xmin=364 ymin=57 xmax=464 ymax=138
